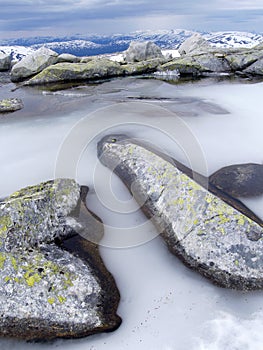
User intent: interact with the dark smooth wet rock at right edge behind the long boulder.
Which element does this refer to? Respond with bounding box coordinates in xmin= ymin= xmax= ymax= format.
xmin=209 ymin=163 xmax=263 ymax=197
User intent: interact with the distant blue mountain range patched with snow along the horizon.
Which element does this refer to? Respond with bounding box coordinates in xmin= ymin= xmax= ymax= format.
xmin=0 ymin=29 xmax=263 ymax=60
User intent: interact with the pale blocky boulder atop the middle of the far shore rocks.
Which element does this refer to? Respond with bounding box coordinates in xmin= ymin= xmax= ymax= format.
xmin=124 ymin=41 xmax=165 ymax=63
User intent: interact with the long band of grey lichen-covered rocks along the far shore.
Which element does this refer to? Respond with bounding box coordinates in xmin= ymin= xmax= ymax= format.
xmin=0 ymin=33 xmax=263 ymax=85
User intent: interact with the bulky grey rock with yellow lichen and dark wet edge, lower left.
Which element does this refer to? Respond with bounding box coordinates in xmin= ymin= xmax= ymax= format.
xmin=0 ymin=179 xmax=120 ymax=340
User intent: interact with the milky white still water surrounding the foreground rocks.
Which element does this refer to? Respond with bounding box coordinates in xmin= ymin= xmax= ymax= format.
xmin=0 ymin=78 xmax=263 ymax=350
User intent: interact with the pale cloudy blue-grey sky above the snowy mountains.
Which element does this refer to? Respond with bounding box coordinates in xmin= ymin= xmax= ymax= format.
xmin=0 ymin=0 xmax=263 ymax=38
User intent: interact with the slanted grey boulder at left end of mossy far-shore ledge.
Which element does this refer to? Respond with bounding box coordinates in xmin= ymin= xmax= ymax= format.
xmin=11 ymin=47 xmax=58 ymax=82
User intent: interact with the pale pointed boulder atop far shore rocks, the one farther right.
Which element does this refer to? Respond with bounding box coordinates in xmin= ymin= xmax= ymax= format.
xmin=178 ymin=33 xmax=212 ymax=55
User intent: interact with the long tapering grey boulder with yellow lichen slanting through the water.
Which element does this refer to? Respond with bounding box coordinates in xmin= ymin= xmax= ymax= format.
xmin=98 ymin=135 xmax=263 ymax=290
